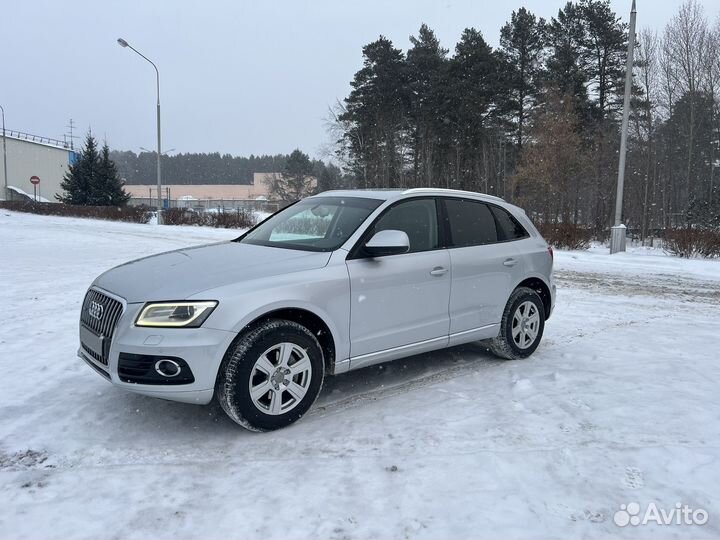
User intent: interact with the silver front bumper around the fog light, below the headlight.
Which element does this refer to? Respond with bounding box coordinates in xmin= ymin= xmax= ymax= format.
xmin=78 ymin=304 xmax=235 ymax=404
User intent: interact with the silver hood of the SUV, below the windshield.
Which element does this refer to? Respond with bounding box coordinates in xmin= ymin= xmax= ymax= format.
xmin=93 ymin=242 xmax=331 ymax=303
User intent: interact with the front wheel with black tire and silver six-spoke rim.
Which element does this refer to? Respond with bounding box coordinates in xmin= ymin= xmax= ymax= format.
xmin=215 ymin=319 xmax=325 ymax=431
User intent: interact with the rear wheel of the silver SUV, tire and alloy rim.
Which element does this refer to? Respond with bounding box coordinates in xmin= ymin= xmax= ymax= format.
xmin=487 ymin=287 xmax=545 ymax=360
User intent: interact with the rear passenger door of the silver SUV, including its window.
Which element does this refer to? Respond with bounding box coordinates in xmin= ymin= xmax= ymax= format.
xmin=442 ymin=198 xmax=522 ymax=342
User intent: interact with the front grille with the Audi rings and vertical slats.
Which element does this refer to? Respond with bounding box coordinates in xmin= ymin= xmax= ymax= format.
xmin=80 ymin=289 xmax=123 ymax=366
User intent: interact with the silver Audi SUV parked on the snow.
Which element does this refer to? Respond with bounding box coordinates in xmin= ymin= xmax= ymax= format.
xmin=78 ymin=189 xmax=555 ymax=431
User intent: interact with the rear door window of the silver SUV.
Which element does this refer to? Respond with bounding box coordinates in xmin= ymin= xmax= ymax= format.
xmin=445 ymin=199 xmax=498 ymax=247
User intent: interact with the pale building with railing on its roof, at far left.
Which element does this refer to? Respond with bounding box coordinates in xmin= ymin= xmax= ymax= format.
xmin=0 ymin=131 xmax=78 ymax=202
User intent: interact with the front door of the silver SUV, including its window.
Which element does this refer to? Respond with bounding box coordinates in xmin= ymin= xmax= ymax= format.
xmin=347 ymin=198 xmax=452 ymax=368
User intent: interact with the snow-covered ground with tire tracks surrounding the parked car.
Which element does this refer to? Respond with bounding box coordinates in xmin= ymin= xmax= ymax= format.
xmin=0 ymin=210 xmax=720 ymax=540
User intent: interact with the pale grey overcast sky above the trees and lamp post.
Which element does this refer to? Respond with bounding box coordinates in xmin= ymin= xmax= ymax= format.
xmin=0 ymin=0 xmax=720 ymax=156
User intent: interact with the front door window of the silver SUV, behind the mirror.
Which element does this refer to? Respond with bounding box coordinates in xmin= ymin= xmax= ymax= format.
xmin=373 ymin=199 xmax=438 ymax=253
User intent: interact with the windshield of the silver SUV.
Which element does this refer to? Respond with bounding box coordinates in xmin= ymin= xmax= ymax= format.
xmin=237 ymin=197 xmax=382 ymax=251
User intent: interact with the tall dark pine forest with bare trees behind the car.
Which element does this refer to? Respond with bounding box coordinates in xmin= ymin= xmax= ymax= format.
xmin=329 ymin=0 xmax=720 ymax=236
